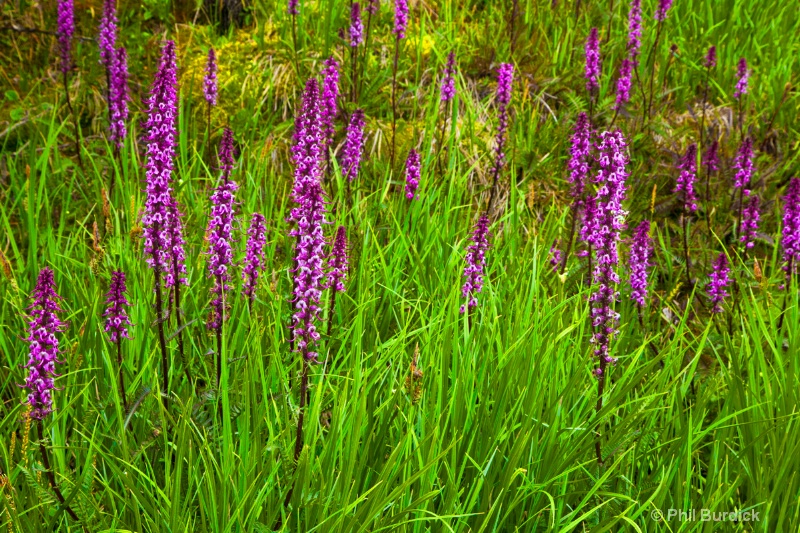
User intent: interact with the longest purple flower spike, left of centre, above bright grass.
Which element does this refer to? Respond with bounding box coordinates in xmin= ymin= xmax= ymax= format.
xmin=289 ymin=78 xmax=327 ymax=360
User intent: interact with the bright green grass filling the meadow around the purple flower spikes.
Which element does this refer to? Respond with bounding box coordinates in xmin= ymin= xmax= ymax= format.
xmin=0 ymin=0 xmax=800 ymax=533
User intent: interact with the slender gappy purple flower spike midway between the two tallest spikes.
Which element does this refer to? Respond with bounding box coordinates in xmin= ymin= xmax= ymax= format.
xmin=206 ymin=128 xmax=239 ymax=330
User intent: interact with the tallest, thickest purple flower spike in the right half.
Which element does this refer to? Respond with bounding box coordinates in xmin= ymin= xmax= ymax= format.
xmin=590 ymin=130 xmax=628 ymax=377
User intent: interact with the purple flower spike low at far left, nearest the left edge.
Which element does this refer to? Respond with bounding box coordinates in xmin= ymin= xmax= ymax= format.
xmin=23 ymin=267 xmax=66 ymax=420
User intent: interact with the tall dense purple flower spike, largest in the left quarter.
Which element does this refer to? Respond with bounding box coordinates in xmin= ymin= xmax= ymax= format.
xmin=142 ymin=41 xmax=178 ymax=276
